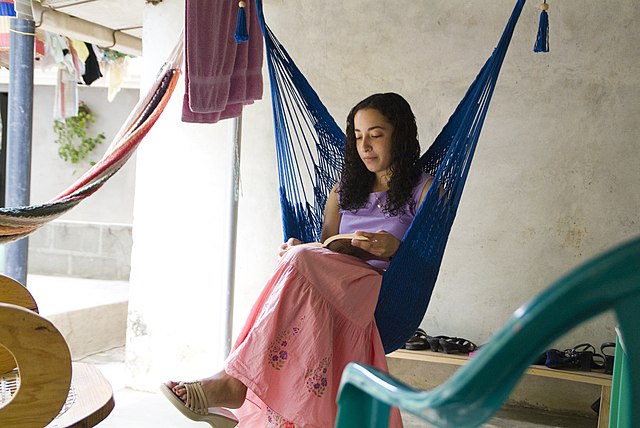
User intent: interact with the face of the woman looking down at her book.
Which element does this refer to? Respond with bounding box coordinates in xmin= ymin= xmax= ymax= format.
xmin=353 ymin=108 xmax=393 ymax=179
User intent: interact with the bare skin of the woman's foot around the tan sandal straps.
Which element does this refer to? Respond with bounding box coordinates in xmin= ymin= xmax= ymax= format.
xmin=166 ymin=371 xmax=247 ymax=409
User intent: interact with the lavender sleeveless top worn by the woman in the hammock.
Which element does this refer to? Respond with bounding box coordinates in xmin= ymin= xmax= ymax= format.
xmin=339 ymin=173 xmax=432 ymax=270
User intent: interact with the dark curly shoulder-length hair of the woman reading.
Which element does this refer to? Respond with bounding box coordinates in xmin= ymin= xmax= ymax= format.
xmin=338 ymin=92 xmax=422 ymax=216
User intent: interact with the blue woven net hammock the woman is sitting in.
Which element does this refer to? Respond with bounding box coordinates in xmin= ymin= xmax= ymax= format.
xmin=256 ymin=0 xmax=525 ymax=353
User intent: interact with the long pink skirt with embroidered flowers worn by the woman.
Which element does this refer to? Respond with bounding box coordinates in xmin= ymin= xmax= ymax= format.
xmin=225 ymin=246 xmax=402 ymax=428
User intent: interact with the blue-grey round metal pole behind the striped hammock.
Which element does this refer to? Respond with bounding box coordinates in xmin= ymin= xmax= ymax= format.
xmin=5 ymin=18 xmax=35 ymax=285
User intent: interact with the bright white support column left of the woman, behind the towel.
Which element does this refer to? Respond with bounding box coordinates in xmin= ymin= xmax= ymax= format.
xmin=126 ymin=2 xmax=230 ymax=391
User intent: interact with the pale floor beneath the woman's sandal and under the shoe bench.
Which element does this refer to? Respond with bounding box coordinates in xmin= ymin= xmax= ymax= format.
xmin=82 ymin=348 xmax=597 ymax=428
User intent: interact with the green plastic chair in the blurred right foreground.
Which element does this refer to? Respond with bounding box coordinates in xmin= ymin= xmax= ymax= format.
xmin=336 ymin=237 xmax=640 ymax=428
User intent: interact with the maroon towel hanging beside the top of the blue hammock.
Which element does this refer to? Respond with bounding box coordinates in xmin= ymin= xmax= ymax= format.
xmin=182 ymin=0 xmax=263 ymax=123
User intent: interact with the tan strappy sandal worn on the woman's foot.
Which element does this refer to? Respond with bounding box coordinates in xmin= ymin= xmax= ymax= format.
xmin=160 ymin=381 xmax=238 ymax=428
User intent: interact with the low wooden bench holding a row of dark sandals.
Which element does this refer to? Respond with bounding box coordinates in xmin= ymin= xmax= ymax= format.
xmin=387 ymin=349 xmax=612 ymax=428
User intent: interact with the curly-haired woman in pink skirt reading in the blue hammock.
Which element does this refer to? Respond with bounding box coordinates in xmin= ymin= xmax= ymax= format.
xmin=161 ymin=93 xmax=432 ymax=427
